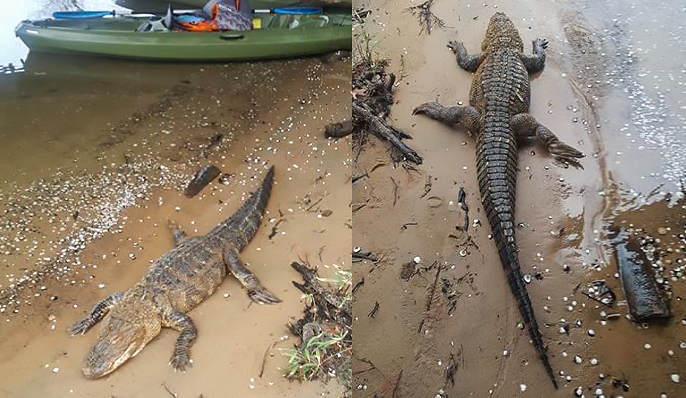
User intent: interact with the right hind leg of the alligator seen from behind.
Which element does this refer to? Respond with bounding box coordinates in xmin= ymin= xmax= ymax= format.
xmin=510 ymin=113 xmax=584 ymax=167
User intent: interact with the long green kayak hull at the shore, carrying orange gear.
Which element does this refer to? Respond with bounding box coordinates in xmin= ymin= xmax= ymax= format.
xmin=15 ymin=10 xmax=352 ymax=61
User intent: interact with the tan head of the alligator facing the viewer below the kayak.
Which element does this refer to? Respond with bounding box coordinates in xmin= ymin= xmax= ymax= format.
xmin=82 ymin=300 xmax=162 ymax=379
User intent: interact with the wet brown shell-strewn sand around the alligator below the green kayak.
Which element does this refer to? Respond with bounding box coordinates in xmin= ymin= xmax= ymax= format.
xmin=0 ymin=58 xmax=351 ymax=398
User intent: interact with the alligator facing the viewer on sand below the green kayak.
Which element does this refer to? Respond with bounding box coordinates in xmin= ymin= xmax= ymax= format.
xmin=68 ymin=166 xmax=281 ymax=379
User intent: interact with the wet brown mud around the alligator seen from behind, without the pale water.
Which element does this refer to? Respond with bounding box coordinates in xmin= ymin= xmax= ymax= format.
xmin=353 ymin=1 xmax=686 ymax=398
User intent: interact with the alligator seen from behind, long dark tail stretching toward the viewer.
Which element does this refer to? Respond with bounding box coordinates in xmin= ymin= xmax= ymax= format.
xmin=413 ymin=12 xmax=584 ymax=388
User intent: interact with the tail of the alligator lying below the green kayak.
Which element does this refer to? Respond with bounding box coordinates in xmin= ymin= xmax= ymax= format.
xmin=208 ymin=166 xmax=274 ymax=251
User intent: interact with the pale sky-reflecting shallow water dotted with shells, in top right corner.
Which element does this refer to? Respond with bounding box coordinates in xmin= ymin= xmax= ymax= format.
xmin=567 ymin=1 xmax=686 ymax=194
